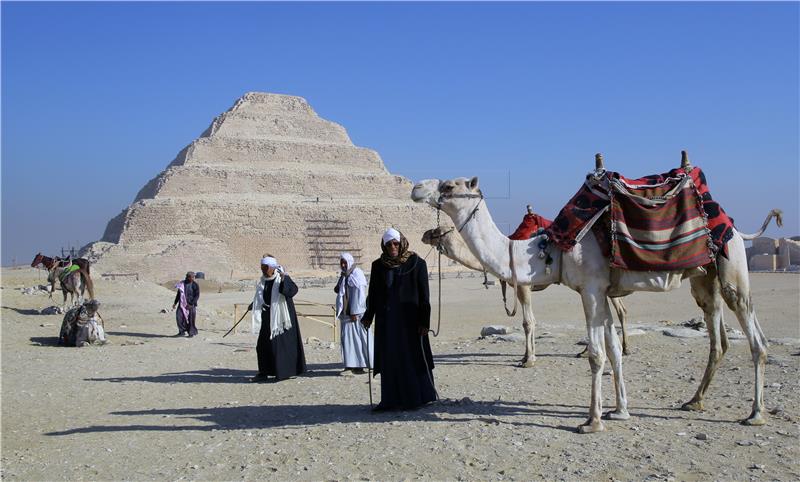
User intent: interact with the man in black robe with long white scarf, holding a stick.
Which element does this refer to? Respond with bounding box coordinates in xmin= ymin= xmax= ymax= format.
xmin=248 ymin=256 xmax=306 ymax=382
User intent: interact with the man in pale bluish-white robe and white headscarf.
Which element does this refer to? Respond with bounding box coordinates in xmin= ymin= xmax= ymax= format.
xmin=334 ymin=253 xmax=374 ymax=375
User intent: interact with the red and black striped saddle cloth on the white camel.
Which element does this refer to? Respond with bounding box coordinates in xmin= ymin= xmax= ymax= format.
xmin=547 ymin=167 xmax=733 ymax=271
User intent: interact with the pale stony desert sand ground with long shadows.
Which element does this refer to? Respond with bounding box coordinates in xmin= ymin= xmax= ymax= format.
xmin=0 ymin=269 xmax=800 ymax=480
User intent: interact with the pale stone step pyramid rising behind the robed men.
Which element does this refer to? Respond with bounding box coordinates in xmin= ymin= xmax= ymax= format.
xmin=85 ymin=92 xmax=444 ymax=280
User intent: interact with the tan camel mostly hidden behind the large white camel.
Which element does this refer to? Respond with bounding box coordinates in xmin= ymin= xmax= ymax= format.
xmin=422 ymin=228 xmax=628 ymax=358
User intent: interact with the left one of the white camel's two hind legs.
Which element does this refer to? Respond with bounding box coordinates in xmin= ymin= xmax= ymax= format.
xmin=682 ymin=270 xmax=728 ymax=410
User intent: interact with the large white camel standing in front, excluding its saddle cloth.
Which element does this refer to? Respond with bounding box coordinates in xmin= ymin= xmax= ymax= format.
xmin=411 ymin=157 xmax=776 ymax=433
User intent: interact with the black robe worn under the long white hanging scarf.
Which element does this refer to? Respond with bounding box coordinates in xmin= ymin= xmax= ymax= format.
xmin=256 ymin=275 xmax=306 ymax=380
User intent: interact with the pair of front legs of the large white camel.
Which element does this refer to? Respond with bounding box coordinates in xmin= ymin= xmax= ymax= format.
xmin=578 ymin=288 xmax=629 ymax=433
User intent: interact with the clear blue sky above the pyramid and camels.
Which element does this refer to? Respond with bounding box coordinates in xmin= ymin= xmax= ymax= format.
xmin=0 ymin=2 xmax=800 ymax=265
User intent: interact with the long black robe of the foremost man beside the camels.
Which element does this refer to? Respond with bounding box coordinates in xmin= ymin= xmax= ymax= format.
xmin=363 ymin=254 xmax=437 ymax=409
